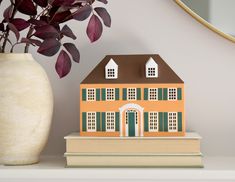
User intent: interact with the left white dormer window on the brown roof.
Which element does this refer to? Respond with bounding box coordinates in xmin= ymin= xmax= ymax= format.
xmin=105 ymin=59 xmax=118 ymax=79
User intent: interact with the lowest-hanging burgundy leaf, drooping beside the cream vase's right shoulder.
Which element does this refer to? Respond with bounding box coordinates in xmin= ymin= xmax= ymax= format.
xmin=55 ymin=50 xmax=72 ymax=78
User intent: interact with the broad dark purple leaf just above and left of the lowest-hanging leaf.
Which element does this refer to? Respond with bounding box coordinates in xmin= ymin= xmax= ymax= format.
xmin=38 ymin=38 xmax=60 ymax=56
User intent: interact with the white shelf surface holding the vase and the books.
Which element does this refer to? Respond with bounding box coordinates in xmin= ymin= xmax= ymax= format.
xmin=0 ymin=156 xmax=235 ymax=182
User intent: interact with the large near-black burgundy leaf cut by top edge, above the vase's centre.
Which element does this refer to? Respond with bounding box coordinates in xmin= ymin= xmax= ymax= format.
xmin=15 ymin=0 xmax=37 ymax=15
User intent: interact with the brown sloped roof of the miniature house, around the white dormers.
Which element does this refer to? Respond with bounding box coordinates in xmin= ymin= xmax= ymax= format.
xmin=82 ymin=54 xmax=184 ymax=84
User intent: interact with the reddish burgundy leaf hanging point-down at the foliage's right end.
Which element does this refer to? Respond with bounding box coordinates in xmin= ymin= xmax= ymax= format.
xmin=86 ymin=15 xmax=103 ymax=42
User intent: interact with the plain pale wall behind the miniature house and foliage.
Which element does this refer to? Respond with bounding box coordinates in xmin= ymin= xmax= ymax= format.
xmin=1 ymin=0 xmax=235 ymax=155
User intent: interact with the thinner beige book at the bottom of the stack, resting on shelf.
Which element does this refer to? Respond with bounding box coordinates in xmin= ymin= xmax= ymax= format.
xmin=65 ymin=153 xmax=203 ymax=167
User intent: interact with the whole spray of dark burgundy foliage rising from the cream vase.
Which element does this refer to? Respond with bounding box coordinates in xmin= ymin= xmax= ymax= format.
xmin=0 ymin=0 xmax=111 ymax=78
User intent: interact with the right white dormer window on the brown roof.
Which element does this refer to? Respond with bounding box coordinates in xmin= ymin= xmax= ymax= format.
xmin=145 ymin=57 xmax=158 ymax=78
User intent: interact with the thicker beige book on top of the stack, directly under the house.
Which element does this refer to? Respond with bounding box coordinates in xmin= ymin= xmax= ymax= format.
xmin=65 ymin=132 xmax=201 ymax=154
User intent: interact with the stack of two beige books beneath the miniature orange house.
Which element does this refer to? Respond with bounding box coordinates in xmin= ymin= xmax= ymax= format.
xmin=65 ymin=132 xmax=203 ymax=167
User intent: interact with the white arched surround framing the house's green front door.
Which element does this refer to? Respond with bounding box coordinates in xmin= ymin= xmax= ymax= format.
xmin=119 ymin=103 xmax=144 ymax=137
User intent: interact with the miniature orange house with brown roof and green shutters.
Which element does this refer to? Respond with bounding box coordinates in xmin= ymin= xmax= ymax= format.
xmin=80 ymin=55 xmax=185 ymax=137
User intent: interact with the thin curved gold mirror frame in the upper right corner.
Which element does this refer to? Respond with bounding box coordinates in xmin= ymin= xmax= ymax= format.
xmin=175 ymin=0 xmax=235 ymax=42
